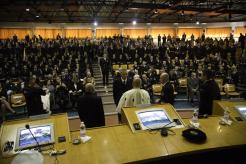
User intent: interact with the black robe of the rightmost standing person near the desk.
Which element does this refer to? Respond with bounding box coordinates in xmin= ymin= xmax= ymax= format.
xmin=199 ymin=80 xmax=221 ymax=115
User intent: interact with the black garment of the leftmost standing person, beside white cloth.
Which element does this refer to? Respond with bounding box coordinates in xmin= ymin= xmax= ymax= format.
xmin=24 ymin=87 xmax=46 ymax=116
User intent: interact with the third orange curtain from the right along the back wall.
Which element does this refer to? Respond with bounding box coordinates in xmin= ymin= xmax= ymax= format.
xmin=177 ymin=28 xmax=202 ymax=39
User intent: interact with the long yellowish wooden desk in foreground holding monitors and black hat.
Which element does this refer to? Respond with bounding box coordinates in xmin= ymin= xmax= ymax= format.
xmin=0 ymin=103 xmax=246 ymax=164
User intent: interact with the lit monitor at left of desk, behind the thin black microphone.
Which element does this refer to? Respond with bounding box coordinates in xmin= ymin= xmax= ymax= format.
xmin=15 ymin=123 xmax=55 ymax=151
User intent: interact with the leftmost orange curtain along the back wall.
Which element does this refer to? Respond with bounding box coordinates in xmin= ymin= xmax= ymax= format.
xmin=0 ymin=28 xmax=32 ymax=39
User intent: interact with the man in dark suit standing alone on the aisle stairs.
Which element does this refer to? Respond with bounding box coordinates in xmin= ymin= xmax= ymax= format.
xmin=100 ymin=54 xmax=110 ymax=88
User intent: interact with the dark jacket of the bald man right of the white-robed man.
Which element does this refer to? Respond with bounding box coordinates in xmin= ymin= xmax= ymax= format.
xmin=161 ymin=82 xmax=174 ymax=105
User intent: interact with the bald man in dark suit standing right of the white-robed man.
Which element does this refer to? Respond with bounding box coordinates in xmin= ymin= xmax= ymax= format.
xmin=160 ymin=73 xmax=174 ymax=105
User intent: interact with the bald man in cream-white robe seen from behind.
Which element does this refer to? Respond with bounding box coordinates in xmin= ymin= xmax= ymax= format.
xmin=116 ymin=77 xmax=150 ymax=113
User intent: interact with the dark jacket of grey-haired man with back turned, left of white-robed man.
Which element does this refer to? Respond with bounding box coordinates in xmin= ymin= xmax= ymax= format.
xmin=78 ymin=94 xmax=105 ymax=128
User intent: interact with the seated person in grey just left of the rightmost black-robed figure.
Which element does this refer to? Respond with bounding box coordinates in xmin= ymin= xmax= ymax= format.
xmin=188 ymin=72 xmax=199 ymax=103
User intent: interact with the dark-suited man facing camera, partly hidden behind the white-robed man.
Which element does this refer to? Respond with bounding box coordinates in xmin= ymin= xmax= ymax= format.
xmin=113 ymin=70 xmax=132 ymax=106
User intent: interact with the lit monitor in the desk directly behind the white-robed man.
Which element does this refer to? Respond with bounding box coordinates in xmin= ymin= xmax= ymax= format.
xmin=136 ymin=108 xmax=175 ymax=130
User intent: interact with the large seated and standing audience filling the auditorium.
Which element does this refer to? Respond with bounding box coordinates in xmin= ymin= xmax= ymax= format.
xmin=0 ymin=34 xmax=246 ymax=123
